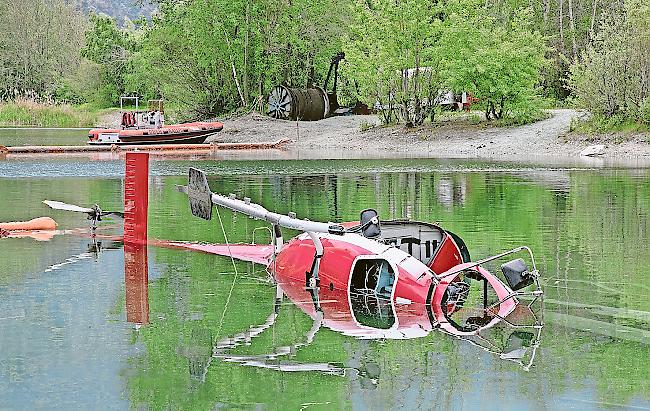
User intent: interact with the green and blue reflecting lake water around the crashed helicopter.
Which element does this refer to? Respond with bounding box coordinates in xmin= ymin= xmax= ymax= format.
xmin=0 ymin=158 xmax=650 ymax=410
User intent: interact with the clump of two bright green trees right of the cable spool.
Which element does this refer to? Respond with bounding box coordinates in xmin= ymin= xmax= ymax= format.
xmin=346 ymin=0 xmax=546 ymax=125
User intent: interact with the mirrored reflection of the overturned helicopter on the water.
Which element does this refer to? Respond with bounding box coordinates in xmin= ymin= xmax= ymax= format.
xmin=175 ymin=268 xmax=543 ymax=387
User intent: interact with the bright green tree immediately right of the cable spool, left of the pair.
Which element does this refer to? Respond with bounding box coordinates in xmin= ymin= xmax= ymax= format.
xmin=345 ymin=0 xmax=440 ymax=126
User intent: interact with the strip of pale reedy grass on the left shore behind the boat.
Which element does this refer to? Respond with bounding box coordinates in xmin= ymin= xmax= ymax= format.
xmin=0 ymin=99 xmax=102 ymax=127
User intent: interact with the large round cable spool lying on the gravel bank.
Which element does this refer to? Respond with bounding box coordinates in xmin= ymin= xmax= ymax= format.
xmin=267 ymin=86 xmax=330 ymax=121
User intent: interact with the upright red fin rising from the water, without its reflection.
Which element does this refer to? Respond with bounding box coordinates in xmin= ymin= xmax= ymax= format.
xmin=124 ymin=153 xmax=149 ymax=244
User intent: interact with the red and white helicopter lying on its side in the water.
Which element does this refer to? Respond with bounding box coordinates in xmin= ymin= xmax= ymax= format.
xmin=176 ymin=168 xmax=543 ymax=367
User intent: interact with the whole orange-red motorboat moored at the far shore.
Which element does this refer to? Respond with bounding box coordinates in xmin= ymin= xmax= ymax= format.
xmin=88 ymin=97 xmax=223 ymax=145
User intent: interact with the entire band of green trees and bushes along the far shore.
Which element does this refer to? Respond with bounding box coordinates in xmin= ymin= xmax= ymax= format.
xmin=0 ymin=0 xmax=650 ymax=130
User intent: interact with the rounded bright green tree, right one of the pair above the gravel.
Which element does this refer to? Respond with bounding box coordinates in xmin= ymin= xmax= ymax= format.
xmin=440 ymin=0 xmax=546 ymax=122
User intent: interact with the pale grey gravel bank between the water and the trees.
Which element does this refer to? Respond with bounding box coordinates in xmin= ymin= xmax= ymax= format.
xmin=213 ymin=109 xmax=650 ymax=162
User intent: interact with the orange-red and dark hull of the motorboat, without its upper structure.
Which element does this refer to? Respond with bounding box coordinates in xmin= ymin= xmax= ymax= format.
xmin=88 ymin=122 xmax=223 ymax=145
